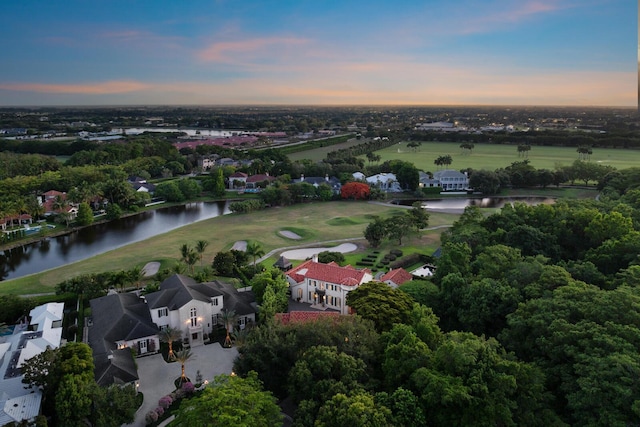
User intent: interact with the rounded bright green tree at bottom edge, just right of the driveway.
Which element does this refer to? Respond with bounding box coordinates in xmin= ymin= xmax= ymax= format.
xmin=173 ymin=372 xmax=282 ymax=427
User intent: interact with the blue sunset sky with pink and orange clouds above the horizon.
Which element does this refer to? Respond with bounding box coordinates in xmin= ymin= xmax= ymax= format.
xmin=0 ymin=0 xmax=639 ymax=107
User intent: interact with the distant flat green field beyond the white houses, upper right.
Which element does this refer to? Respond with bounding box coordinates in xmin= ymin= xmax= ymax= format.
xmin=372 ymin=142 xmax=640 ymax=172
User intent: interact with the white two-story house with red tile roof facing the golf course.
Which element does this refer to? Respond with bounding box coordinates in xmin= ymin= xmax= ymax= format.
xmin=285 ymin=256 xmax=373 ymax=314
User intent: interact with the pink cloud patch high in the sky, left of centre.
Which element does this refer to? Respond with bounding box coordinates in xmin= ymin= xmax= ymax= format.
xmin=198 ymin=37 xmax=307 ymax=62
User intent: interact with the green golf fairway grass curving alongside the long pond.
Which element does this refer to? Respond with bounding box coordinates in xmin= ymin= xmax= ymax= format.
xmin=0 ymin=201 xmax=458 ymax=295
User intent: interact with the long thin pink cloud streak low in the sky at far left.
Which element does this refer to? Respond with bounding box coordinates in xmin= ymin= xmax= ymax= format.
xmin=0 ymin=81 xmax=150 ymax=95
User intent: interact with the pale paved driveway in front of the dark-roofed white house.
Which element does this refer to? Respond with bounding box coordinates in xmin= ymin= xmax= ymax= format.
xmin=129 ymin=343 xmax=238 ymax=427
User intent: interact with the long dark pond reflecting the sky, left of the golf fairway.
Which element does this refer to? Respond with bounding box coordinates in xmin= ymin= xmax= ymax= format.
xmin=0 ymin=202 xmax=230 ymax=280
